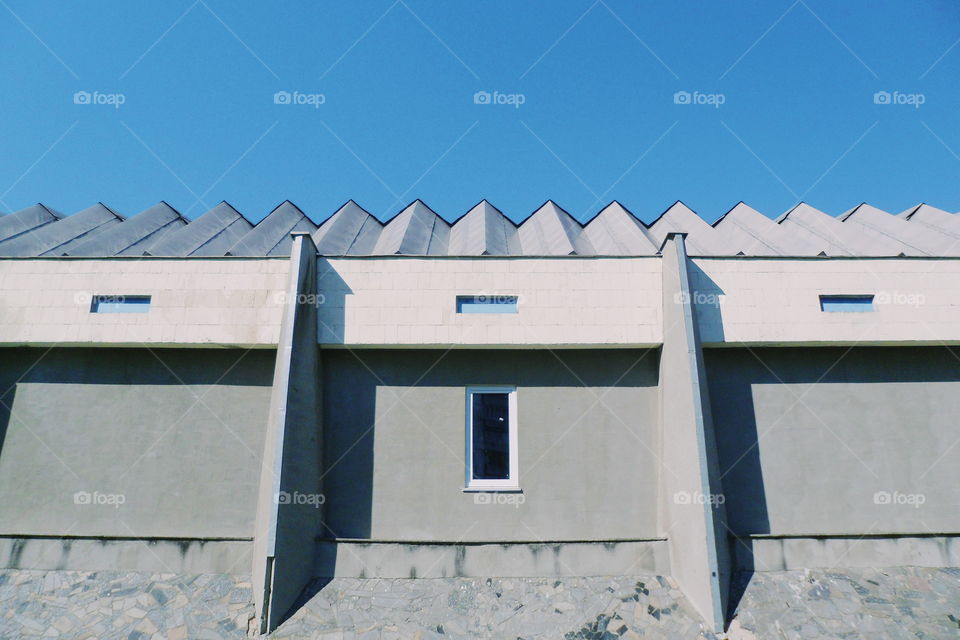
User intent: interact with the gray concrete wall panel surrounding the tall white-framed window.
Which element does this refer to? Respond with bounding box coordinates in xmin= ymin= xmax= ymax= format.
xmin=323 ymin=349 xmax=659 ymax=541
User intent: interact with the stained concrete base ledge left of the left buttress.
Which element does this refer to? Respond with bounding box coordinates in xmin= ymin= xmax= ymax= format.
xmin=0 ymin=536 xmax=253 ymax=575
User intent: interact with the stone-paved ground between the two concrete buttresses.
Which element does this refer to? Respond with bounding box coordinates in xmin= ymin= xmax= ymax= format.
xmin=270 ymin=577 xmax=715 ymax=640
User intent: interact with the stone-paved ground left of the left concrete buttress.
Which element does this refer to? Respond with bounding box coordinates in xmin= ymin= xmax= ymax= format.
xmin=0 ymin=570 xmax=253 ymax=640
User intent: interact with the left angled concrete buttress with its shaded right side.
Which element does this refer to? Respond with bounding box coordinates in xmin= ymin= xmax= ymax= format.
xmin=253 ymin=233 xmax=323 ymax=633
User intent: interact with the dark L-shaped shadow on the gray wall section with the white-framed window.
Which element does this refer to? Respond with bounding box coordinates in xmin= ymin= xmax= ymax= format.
xmin=320 ymin=349 xmax=657 ymax=547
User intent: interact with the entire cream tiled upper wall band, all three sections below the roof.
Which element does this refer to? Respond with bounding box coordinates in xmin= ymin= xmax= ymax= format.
xmin=0 ymin=256 xmax=960 ymax=346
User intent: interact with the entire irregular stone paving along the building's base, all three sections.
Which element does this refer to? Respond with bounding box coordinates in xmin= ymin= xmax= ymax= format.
xmin=0 ymin=567 xmax=960 ymax=640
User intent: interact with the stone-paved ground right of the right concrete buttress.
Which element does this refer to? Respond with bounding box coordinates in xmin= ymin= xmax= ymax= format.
xmin=730 ymin=567 xmax=960 ymax=640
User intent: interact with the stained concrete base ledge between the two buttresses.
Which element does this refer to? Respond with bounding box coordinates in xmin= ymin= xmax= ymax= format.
xmin=315 ymin=538 xmax=670 ymax=578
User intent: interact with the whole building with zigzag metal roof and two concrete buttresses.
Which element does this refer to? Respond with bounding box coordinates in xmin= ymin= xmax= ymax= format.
xmin=0 ymin=201 xmax=960 ymax=631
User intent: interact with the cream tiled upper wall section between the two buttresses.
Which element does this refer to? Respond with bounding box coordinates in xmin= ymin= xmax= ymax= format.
xmin=318 ymin=257 xmax=662 ymax=346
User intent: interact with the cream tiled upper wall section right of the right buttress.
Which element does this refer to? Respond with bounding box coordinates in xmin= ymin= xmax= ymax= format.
xmin=690 ymin=258 xmax=960 ymax=344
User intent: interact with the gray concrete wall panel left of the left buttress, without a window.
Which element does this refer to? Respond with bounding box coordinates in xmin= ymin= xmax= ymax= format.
xmin=0 ymin=348 xmax=274 ymax=538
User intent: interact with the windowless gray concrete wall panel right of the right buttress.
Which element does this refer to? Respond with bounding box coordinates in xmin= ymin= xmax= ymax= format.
xmin=706 ymin=347 xmax=960 ymax=535
